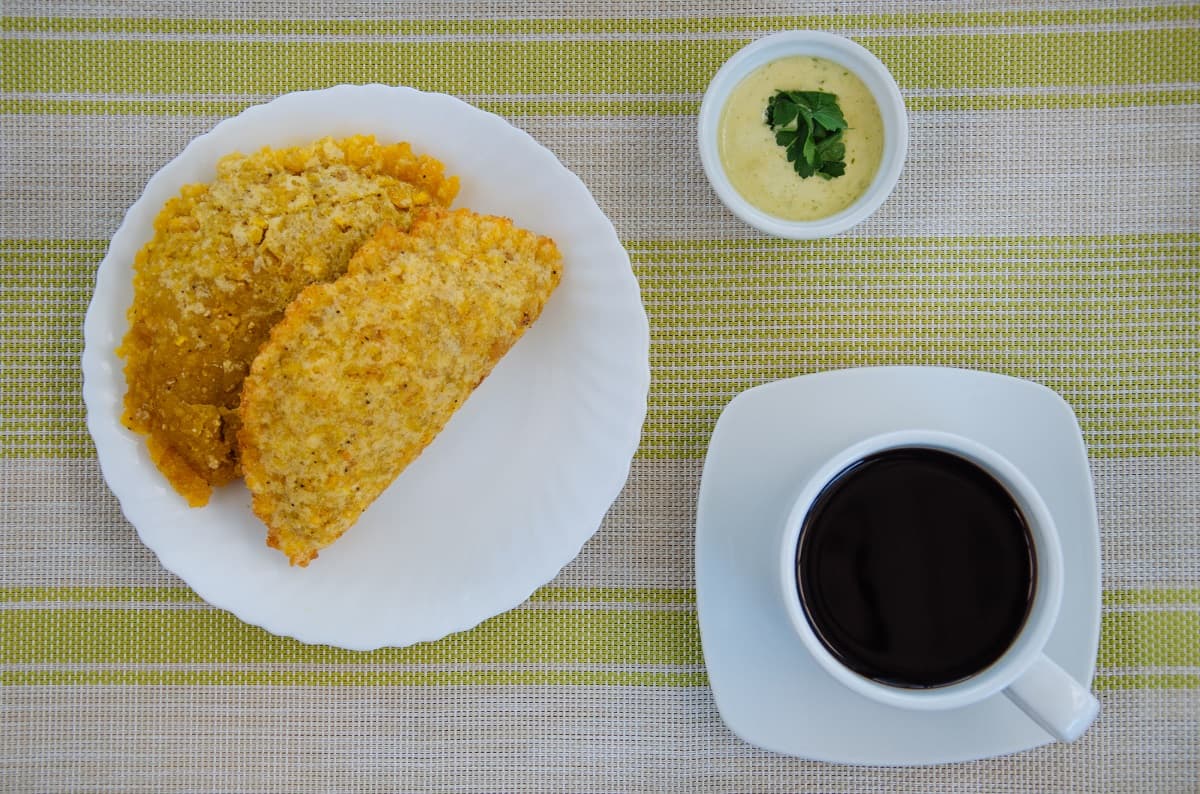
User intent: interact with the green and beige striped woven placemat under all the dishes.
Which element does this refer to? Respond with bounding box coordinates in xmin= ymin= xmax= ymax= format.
xmin=0 ymin=0 xmax=1200 ymax=792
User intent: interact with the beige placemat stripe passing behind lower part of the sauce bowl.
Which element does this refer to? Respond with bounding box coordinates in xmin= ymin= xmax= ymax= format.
xmin=5 ymin=107 xmax=1200 ymax=241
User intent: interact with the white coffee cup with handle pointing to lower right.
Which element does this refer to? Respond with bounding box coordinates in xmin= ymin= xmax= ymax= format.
xmin=779 ymin=429 xmax=1099 ymax=741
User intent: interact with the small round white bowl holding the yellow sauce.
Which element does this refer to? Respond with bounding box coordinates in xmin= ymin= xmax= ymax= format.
xmin=698 ymin=30 xmax=908 ymax=240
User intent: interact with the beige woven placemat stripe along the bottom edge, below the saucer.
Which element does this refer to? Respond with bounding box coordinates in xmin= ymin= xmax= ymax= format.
xmin=4 ymin=686 xmax=1200 ymax=794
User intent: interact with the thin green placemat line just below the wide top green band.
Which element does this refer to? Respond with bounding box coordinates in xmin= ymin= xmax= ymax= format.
xmin=7 ymin=89 xmax=1200 ymax=119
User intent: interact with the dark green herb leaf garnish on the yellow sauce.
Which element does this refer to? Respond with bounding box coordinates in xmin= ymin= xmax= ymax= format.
xmin=767 ymin=91 xmax=846 ymax=179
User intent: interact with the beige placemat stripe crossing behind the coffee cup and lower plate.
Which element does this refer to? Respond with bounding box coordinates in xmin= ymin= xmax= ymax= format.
xmin=0 ymin=457 xmax=1200 ymax=589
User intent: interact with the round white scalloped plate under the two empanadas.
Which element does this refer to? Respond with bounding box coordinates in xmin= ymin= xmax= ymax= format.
xmin=83 ymin=85 xmax=649 ymax=650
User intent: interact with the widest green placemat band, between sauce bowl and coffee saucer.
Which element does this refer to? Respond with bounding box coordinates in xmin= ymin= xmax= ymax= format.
xmin=0 ymin=234 xmax=1200 ymax=459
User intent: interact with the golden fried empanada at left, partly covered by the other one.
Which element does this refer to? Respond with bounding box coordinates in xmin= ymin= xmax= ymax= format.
xmin=118 ymin=136 xmax=458 ymax=506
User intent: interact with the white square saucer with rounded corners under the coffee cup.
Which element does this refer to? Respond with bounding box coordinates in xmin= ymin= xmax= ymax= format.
xmin=696 ymin=367 xmax=1100 ymax=765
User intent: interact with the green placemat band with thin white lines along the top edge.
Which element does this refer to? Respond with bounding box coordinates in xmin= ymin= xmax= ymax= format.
xmin=0 ymin=6 xmax=1200 ymax=115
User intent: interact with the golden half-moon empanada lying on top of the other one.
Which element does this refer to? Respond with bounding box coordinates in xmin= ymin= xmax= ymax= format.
xmin=240 ymin=210 xmax=562 ymax=565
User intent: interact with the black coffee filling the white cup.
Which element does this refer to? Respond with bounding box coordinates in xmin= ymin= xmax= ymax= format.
xmin=797 ymin=447 xmax=1036 ymax=688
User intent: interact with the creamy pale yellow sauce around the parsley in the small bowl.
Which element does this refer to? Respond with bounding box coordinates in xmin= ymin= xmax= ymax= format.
xmin=718 ymin=55 xmax=883 ymax=221
